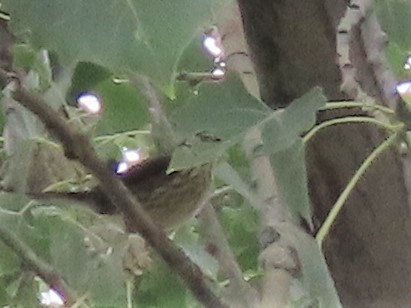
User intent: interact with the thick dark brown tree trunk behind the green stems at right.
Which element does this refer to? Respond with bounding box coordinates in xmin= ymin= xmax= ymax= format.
xmin=238 ymin=0 xmax=411 ymax=307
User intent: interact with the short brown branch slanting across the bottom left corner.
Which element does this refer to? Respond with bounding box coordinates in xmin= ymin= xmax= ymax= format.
xmin=0 ymin=225 xmax=75 ymax=305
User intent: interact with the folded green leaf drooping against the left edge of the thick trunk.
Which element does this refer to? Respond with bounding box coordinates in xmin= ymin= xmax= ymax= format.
xmin=262 ymin=88 xmax=326 ymax=224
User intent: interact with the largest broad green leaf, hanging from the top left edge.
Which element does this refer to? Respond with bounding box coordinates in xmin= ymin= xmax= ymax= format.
xmin=2 ymin=0 xmax=229 ymax=87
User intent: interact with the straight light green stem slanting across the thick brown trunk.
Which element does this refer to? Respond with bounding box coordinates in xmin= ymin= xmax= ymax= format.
xmin=315 ymin=134 xmax=398 ymax=246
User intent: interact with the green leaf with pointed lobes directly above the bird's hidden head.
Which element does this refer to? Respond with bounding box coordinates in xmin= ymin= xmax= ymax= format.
xmin=171 ymin=75 xmax=271 ymax=141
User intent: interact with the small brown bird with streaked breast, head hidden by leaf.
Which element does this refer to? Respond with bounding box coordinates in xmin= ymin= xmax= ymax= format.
xmin=34 ymin=156 xmax=211 ymax=229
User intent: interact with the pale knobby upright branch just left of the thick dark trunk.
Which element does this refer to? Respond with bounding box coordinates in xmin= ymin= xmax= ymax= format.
xmin=245 ymin=129 xmax=299 ymax=307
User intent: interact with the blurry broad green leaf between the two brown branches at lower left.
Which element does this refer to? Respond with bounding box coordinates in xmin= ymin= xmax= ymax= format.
xmin=32 ymin=207 xmax=130 ymax=307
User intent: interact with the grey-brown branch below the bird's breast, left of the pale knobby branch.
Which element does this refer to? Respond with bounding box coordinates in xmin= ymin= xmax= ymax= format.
xmin=198 ymin=203 xmax=258 ymax=307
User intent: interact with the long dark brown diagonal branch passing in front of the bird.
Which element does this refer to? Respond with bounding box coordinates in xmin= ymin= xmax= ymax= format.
xmin=9 ymin=86 xmax=225 ymax=307
